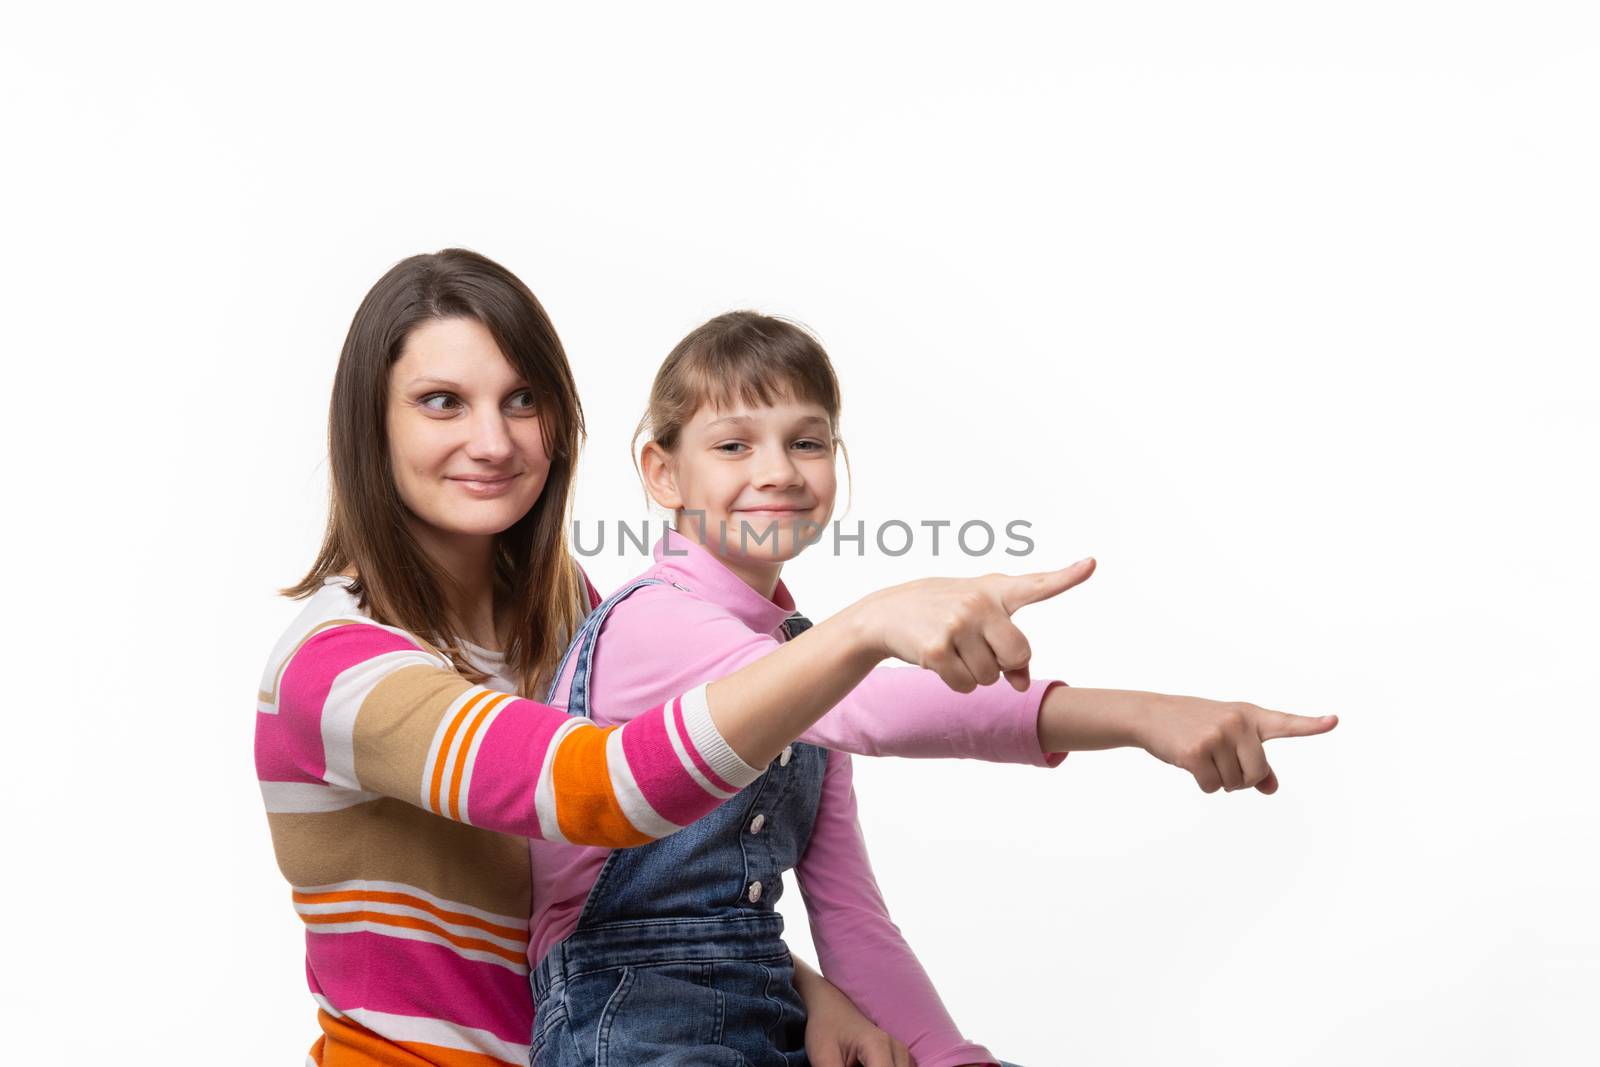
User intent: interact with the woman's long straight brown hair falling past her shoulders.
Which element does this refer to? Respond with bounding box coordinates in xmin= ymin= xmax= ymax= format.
xmin=283 ymin=248 xmax=587 ymax=696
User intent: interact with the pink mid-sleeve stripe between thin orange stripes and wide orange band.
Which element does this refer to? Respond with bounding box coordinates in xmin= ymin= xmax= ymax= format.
xmin=467 ymin=697 xmax=566 ymax=838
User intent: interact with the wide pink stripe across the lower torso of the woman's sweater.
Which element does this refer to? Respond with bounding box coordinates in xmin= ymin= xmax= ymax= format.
xmin=306 ymin=931 xmax=533 ymax=1045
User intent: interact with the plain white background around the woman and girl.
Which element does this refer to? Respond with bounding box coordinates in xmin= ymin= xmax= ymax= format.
xmin=0 ymin=2 xmax=1600 ymax=1067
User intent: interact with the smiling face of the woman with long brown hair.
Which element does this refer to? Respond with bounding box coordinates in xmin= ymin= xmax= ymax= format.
xmin=389 ymin=318 xmax=550 ymax=547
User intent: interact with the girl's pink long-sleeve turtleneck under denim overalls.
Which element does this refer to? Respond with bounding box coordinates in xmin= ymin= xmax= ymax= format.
xmin=528 ymin=531 xmax=1064 ymax=1067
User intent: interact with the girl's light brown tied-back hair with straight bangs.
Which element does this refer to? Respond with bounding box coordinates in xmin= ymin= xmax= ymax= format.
xmin=632 ymin=310 xmax=850 ymax=510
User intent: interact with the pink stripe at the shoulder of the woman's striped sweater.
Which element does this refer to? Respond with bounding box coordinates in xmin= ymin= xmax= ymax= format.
xmin=256 ymin=622 xmax=416 ymax=782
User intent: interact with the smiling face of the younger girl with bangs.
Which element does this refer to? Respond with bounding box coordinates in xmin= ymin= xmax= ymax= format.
xmin=643 ymin=402 xmax=838 ymax=593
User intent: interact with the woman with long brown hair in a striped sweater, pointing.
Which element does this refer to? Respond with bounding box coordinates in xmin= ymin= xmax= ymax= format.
xmin=256 ymin=250 xmax=1091 ymax=1067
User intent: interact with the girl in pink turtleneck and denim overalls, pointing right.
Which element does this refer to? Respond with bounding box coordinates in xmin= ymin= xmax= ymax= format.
xmin=531 ymin=312 xmax=1331 ymax=1067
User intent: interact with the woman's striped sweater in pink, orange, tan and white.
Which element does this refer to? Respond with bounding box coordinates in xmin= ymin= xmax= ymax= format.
xmin=256 ymin=579 xmax=760 ymax=1067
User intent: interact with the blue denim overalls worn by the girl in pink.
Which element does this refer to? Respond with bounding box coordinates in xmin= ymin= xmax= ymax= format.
xmin=530 ymin=577 xmax=827 ymax=1067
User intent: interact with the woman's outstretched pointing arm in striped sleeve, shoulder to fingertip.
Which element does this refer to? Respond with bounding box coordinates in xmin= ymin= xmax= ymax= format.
xmin=256 ymin=565 xmax=1093 ymax=848
